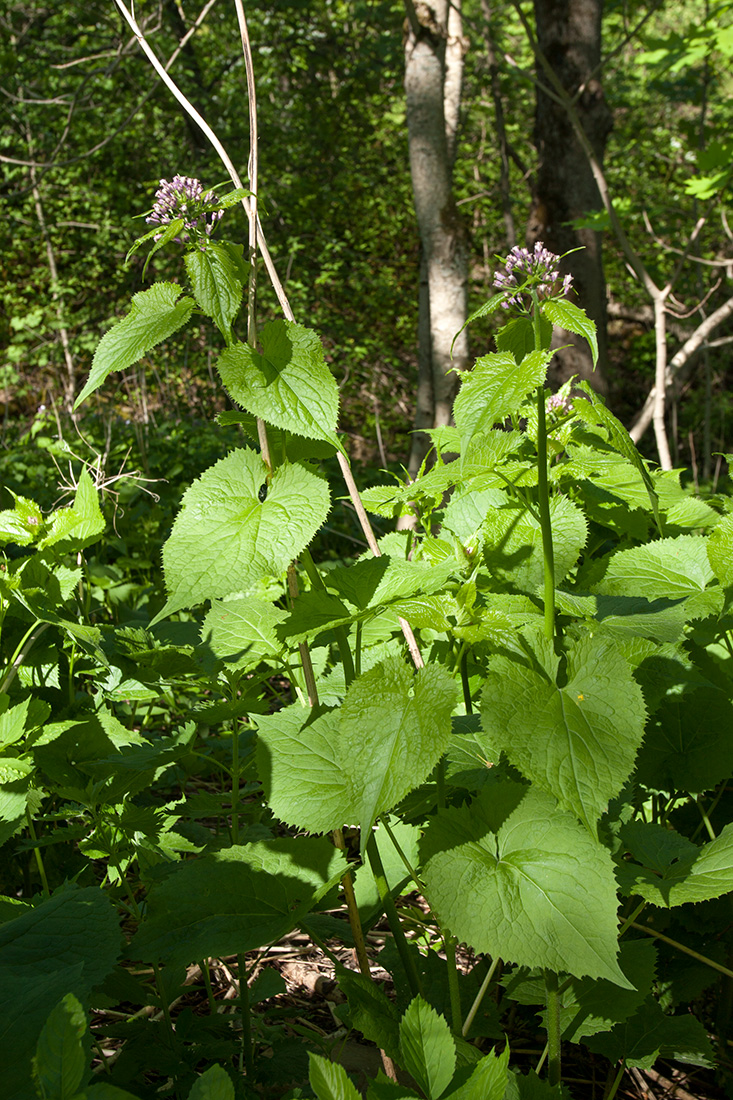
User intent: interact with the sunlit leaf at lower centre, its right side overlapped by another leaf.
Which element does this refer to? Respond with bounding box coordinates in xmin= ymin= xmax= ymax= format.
xmin=258 ymin=704 xmax=355 ymax=833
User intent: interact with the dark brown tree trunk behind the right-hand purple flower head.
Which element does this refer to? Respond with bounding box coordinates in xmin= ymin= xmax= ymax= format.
xmin=527 ymin=0 xmax=612 ymax=393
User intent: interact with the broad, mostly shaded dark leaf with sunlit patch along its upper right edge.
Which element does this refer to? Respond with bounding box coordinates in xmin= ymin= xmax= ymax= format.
xmin=129 ymin=837 xmax=347 ymax=966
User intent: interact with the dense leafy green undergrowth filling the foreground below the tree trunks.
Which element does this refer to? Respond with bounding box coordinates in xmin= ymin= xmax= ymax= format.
xmin=0 ymin=189 xmax=733 ymax=1100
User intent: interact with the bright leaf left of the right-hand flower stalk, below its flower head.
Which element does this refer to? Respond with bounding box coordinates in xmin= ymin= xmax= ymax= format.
xmin=453 ymin=351 xmax=551 ymax=450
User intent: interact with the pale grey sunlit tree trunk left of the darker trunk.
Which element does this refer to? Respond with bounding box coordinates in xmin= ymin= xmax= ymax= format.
xmin=405 ymin=0 xmax=468 ymax=476
